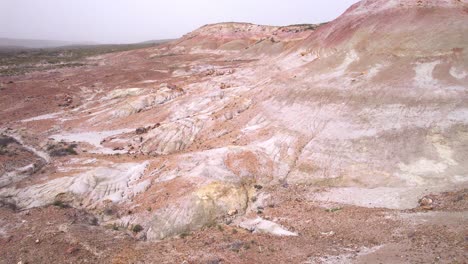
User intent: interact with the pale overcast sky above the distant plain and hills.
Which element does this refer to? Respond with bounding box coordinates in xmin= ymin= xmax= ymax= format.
xmin=0 ymin=0 xmax=357 ymax=43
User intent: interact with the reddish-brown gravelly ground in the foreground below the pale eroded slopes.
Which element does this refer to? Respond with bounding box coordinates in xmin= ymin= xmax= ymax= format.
xmin=0 ymin=187 xmax=468 ymax=263
